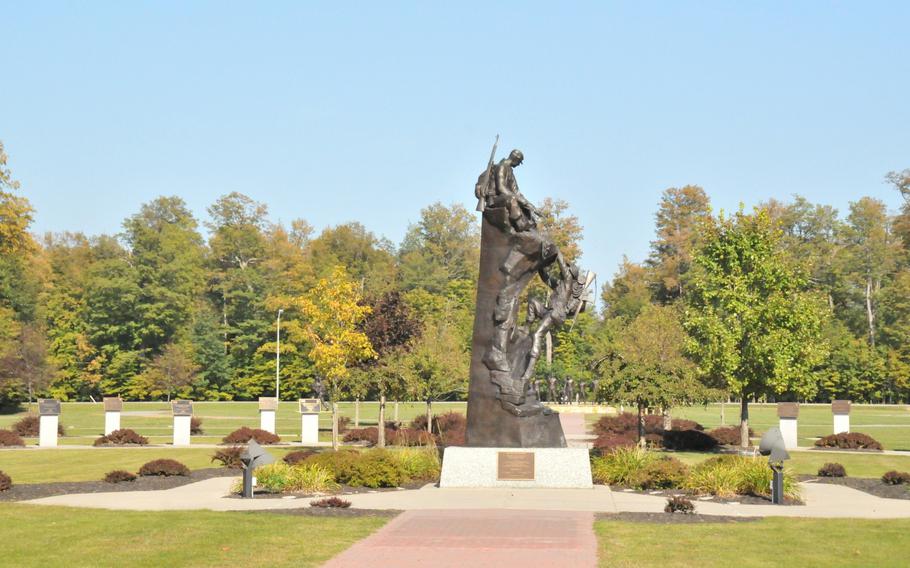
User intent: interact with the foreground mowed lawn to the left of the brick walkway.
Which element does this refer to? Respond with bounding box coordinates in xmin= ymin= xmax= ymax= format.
xmin=0 ymin=503 xmax=388 ymax=568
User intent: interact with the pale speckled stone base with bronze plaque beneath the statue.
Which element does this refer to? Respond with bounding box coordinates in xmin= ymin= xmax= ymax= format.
xmin=439 ymin=446 xmax=593 ymax=489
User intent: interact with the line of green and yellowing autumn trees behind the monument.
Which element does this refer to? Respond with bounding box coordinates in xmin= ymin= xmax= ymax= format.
xmin=0 ymin=139 xmax=910 ymax=412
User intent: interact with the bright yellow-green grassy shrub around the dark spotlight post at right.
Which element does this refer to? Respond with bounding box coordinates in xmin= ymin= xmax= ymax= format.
xmin=683 ymin=455 xmax=799 ymax=499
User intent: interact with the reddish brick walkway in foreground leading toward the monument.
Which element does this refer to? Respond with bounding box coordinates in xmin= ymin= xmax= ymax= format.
xmin=325 ymin=509 xmax=597 ymax=568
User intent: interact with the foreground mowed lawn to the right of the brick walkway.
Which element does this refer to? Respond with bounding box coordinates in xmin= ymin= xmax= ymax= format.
xmin=594 ymin=518 xmax=910 ymax=568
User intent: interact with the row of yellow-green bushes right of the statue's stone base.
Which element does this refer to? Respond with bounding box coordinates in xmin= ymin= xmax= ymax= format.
xmin=591 ymin=447 xmax=799 ymax=498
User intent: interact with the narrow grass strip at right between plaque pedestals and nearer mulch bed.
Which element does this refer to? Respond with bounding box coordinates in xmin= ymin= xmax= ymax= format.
xmin=668 ymin=451 xmax=910 ymax=477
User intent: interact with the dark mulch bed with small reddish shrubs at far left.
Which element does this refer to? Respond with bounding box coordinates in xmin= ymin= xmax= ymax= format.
xmin=0 ymin=467 xmax=238 ymax=501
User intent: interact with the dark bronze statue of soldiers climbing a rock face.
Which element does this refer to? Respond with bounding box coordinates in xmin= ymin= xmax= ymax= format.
xmin=466 ymin=142 xmax=590 ymax=448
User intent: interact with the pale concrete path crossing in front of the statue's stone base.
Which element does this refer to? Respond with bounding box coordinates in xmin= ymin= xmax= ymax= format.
xmin=27 ymin=477 xmax=910 ymax=519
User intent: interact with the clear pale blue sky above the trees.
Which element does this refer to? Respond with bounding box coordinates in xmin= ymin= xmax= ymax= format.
xmin=0 ymin=0 xmax=910 ymax=281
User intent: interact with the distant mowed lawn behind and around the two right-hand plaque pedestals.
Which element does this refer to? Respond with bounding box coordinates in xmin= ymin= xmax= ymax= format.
xmin=672 ymin=403 xmax=910 ymax=450
